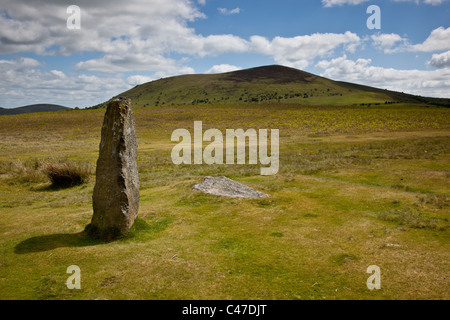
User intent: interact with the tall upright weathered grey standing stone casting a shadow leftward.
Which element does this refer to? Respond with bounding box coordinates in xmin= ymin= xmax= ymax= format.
xmin=87 ymin=97 xmax=139 ymax=240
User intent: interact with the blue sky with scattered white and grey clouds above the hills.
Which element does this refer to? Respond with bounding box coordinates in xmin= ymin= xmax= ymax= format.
xmin=0 ymin=0 xmax=450 ymax=108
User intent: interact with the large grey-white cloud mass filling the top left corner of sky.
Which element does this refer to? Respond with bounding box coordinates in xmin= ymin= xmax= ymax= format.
xmin=0 ymin=0 xmax=204 ymax=69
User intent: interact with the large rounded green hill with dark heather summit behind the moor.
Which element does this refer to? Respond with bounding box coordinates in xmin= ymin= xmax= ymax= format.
xmin=92 ymin=65 xmax=450 ymax=109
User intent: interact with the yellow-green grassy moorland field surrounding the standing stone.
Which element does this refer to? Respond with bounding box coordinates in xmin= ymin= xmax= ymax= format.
xmin=0 ymin=103 xmax=450 ymax=299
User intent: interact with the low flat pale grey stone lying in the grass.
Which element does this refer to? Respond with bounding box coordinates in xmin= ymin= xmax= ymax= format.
xmin=192 ymin=176 xmax=269 ymax=198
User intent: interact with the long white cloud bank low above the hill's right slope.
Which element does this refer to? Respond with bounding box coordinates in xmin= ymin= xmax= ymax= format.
xmin=316 ymin=55 xmax=450 ymax=98
